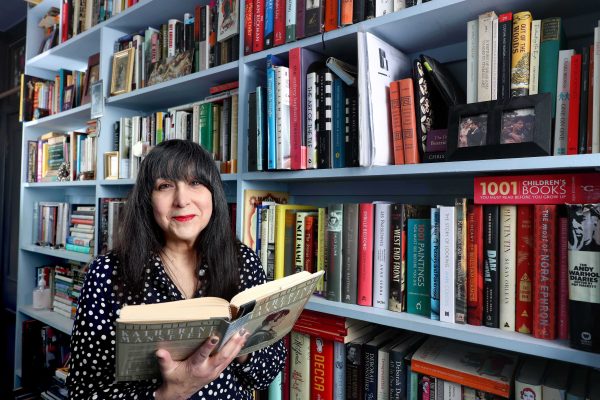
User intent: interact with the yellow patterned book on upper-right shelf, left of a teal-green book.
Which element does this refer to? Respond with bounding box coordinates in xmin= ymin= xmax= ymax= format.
xmin=510 ymin=11 xmax=532 ymax=96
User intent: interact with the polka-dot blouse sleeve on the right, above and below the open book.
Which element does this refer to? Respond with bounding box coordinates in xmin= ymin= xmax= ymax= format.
xmin=231 ymin=245 xmax=286 ymax=389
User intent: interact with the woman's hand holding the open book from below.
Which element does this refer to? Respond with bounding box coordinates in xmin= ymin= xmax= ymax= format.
xmin=155 ymin=330 xmax=249 ymax=400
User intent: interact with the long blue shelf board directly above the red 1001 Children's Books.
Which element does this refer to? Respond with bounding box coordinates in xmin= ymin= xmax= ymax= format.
xmin=242 ymin=154 xmax=600 ymax=182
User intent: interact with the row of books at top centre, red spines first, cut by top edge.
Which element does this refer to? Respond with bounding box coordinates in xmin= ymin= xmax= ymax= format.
xmin=244 ymin=0 xmax=429 ymax=55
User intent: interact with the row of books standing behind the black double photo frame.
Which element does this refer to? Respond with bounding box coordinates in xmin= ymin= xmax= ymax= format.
xmin=467 ymin=11 xmax=600 ymax=155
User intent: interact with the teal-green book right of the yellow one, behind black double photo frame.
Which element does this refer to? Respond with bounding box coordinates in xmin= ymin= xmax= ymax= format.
xmin=538 ymin=17 xmax=565 ymax=118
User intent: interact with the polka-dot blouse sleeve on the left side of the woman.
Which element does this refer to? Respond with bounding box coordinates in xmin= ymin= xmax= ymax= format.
xmin=67 ymin=256 xmax=158 ymax=400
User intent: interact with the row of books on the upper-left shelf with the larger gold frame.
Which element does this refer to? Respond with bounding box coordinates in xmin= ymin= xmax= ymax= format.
xmin=112 ymin=0 xmax=239 ymax=94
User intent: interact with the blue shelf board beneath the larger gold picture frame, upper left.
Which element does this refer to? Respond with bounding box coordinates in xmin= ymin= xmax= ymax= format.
xmin=107 ymin=61 xmax=239 ymax=111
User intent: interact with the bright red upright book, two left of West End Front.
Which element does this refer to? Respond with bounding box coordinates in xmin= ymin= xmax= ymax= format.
xmin=357 ymin=203 xmax=374 ymax=307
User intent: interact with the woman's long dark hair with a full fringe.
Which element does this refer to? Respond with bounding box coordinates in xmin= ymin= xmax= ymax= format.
xmin=115 ymin=140 xmax=239 ymax=300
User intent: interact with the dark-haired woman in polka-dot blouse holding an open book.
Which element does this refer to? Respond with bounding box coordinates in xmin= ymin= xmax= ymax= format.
xmin=68 ymin=140 xmax=285 ymax=399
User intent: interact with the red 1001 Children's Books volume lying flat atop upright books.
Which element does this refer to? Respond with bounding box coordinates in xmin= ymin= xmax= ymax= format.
xmin=473 ymin=172 xmax=600 ymax=204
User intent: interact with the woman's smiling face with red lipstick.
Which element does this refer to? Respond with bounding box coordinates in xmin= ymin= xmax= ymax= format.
xmin=152 ymin=179 xmax=213 ymax=245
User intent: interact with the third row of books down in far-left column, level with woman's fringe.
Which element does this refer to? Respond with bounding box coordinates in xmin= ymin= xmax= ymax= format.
xmin=26 ymin=126 xmax=97 ymax=183
